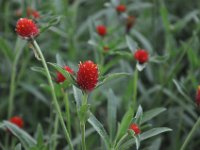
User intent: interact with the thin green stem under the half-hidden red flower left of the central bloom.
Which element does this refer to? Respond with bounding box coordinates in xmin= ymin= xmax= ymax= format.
xmin=63 ymin=90 xmax=71 ymax=137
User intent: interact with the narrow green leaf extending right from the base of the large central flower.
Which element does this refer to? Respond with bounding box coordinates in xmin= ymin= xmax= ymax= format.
xmin=96 ymin=72 xmax=131 ymax=88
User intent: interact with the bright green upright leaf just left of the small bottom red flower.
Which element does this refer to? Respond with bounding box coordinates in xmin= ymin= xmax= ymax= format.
xmin=115 ymin=107 xmax=134 ymax=141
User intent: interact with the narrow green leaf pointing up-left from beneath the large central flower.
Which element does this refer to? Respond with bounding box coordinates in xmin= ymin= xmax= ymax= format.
xmin=48 ymin=62 xmax=75 ymax=84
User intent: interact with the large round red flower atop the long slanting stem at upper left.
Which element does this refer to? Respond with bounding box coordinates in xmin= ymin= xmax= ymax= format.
xmin=15 ymin=18 xmax=39 ymax=39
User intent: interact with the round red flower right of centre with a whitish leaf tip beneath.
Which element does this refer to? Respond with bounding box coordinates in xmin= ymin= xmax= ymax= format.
xmin=134 ymin=49 xmax=149 ymax=64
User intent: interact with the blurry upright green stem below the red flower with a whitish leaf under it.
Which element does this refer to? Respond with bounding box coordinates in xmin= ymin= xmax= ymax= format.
xmin=133 ymin=69 xmax=138 ymax=111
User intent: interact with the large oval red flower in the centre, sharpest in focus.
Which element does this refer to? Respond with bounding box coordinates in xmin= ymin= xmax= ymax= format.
xmin=76 ymin=60 xmax=98 ymax=92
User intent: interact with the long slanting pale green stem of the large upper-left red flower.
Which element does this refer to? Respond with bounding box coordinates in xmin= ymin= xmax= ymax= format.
xmin=32 ymin=40 xmax=74 ymax=150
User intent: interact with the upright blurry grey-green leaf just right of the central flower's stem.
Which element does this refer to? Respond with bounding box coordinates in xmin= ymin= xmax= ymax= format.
xmin=106 ymin=89 xmax=117 ymax=140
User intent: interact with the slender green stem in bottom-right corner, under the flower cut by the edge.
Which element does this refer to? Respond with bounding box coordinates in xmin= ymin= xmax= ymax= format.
xmin=180 ymin=117 xmax=200 ymax=150
